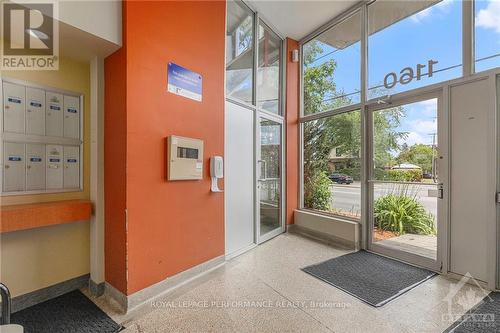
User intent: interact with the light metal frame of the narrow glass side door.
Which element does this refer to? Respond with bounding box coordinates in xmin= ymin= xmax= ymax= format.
xmin=254 ymin=110 xmax=286 ymax=244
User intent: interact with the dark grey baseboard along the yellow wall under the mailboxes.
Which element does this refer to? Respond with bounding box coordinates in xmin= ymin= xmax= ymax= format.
xmin=3 ymin=274 xmax=90 ymax=313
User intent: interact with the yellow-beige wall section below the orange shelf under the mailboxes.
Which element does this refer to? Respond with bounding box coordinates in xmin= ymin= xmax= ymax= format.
xmin=0 ymin=222 xmax=90 ymax=296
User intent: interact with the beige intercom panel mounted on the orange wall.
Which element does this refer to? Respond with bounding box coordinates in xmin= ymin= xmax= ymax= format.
xmin=168 ymin=135 xmax=203 ymax=180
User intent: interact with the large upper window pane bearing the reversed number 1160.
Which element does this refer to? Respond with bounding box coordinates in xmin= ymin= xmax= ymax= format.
xmin=368 ymin=0 xmax=462 ymax=99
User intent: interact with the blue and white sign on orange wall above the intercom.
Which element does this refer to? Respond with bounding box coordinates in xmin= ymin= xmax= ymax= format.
xmin=167 ymin=62 xmax=203 ymax=102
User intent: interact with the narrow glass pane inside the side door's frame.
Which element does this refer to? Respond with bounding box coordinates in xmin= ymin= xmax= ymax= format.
xmin=258 ymin=119 xmax=281 ymax=236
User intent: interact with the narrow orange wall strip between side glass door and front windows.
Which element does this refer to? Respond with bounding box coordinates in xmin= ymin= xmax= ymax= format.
xmin=286 ymin=38 xmax=300 ymax=224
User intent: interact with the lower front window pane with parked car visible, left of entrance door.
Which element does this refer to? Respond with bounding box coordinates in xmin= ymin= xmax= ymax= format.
xmin=304 ymin=110 xmax=361 ymax=219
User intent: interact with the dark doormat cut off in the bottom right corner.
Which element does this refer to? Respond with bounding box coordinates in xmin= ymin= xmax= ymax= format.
xmin=445 ymin=293 xmax=500 ymax=333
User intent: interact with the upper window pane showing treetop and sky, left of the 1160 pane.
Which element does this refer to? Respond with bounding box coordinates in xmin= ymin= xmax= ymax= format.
xmin=303 ymin=12 xmax=361 ymax=115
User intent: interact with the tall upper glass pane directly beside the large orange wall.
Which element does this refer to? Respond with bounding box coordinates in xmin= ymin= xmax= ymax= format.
xmin=226 ymin=1 xmax=254 ymax=104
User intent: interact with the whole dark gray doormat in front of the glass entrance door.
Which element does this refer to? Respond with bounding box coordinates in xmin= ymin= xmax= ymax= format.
xmin=302 ymin=251 xmax=436 ymax=307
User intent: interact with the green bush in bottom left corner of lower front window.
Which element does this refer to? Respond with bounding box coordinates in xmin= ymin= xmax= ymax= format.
xmin=304 ymin=171 xmax=332 ymax=211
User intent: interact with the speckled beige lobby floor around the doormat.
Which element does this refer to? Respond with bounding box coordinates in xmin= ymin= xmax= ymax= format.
xmin=89 ymin=234 xmax=484 ymax=333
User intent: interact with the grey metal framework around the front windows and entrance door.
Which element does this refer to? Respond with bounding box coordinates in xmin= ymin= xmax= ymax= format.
xmin=298 ymin=0 xmax=500 ymax=278
